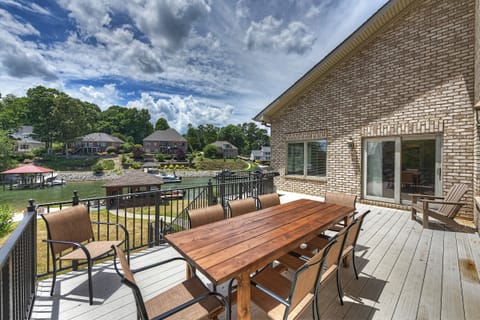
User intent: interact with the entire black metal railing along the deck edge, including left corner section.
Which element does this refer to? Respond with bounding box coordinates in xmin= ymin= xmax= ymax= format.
xmin=0 ymin=172 xmax=278 ymax=319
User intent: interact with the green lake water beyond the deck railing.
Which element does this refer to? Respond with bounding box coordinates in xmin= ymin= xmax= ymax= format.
xmin=0 ymin=177 xmax=209 ymax=212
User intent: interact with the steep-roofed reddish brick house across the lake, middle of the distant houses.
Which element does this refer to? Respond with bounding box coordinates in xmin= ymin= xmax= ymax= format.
xmin=143 ymin=128 xmax=188 ymax=155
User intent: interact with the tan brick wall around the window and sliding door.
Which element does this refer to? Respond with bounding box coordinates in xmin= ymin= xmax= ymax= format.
xmin=271 ymin=0 xmax=476 ymax=215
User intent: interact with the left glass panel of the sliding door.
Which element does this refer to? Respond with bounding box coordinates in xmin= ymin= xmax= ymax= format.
xmin=365 ymin=141 xmax=395 ymax=200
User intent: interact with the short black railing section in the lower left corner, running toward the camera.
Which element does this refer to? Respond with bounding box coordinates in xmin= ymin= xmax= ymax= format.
xmin=0 ymin=207 xmax=37 ymax=319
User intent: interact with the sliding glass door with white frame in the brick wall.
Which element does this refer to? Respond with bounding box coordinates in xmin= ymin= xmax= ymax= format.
xmin=363 ymin=136 xmax=442 ymax=203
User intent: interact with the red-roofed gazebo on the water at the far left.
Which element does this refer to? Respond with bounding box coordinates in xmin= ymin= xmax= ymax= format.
xmin=0 ymin=164 xmax=53 ymax=189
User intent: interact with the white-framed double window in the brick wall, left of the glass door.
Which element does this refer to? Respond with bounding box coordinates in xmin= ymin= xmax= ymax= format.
xmin=287 ymin=140 xmax=327 ymax=177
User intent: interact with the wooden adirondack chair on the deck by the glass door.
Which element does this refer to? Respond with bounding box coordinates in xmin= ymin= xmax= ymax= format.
xmin=411 ymin=183 xmax=468 ymax=229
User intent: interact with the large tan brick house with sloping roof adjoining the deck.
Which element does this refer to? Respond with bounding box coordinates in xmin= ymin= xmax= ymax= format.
xmin=254 ymin=0 xmax=480 ymax=226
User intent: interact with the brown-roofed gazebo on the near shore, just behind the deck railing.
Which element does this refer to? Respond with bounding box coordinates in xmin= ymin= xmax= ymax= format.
xmin=103 ymin=171 xmax=163 ymax=209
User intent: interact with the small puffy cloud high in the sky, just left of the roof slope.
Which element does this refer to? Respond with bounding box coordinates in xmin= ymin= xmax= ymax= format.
xmin=245 ymin=16 xmax=316 ymax=55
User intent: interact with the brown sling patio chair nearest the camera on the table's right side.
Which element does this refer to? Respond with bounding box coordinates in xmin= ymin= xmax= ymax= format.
xmin=234 ymin=239 xmax=336 ymax=320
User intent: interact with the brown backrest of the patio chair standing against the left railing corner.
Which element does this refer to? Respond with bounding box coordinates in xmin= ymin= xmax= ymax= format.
xmin=41 ymin=205 xmax=95 ymax=255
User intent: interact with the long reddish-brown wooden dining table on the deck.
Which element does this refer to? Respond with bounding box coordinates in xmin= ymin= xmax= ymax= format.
xmin=165 ymin=199 xmax=355 ymax=319
